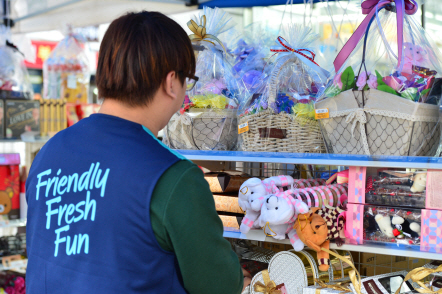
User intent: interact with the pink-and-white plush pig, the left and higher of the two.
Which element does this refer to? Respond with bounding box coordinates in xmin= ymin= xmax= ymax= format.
xmin=238 ymin=176 xmax=294 ymax=234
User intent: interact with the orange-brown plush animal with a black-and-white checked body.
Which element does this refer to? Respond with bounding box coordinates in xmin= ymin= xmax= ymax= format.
xmin=293 ymin=205 xmax=344 ymax=271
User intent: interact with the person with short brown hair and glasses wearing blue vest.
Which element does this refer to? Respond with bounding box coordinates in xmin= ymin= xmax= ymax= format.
xmin=26 ymin=11 xmax=250 ymax=294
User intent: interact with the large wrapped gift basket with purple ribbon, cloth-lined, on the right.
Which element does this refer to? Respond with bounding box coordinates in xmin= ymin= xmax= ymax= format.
xmin=315 ymin=0 xmax=442 ymax=156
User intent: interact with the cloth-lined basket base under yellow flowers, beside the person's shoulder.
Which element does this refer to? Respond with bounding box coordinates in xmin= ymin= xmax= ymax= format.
xmin=164 ymin=108 xmax=238 ymax=150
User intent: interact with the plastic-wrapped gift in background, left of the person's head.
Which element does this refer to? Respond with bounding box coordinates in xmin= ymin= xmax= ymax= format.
xmin=43 ymin=32 xmax=90 ymax=104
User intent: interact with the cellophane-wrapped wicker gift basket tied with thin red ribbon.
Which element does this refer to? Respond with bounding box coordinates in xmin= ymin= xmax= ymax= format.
xmin=238 ymin=25 xmax=328 ymax=153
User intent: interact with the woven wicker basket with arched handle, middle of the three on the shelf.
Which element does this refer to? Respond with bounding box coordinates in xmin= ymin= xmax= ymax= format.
xmin=240 ymin=55 xmax=325 ymax=153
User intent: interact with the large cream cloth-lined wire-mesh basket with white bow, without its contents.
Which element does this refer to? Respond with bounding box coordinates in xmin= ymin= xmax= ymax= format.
xmin=315 ymin=89 xmax=441 ymax=156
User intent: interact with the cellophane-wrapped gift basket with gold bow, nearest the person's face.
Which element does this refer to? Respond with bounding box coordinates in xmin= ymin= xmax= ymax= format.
xmin=165 ymin=7 xmax=240 ymax=150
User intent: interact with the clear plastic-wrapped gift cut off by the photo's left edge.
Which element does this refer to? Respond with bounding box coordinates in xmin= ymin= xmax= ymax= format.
xmin=0 ymin=41 xmax=34 ymax=99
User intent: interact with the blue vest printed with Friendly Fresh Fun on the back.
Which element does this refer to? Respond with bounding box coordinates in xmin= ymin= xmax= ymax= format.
xmin=26 ymin=114 xmax=186 ymax=294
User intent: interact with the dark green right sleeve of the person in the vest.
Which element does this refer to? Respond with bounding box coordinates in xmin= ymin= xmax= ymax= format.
xmin=150 ymin=160 xmax=244 ymax=294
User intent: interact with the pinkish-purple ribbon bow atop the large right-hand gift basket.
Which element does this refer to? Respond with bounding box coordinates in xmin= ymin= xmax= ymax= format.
xmin=333 ymin=0 xmax=417 ymax=72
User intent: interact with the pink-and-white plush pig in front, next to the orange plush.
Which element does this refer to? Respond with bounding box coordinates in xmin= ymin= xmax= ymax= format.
xmin=259 ymin=190 xmax=308 ymax=251
